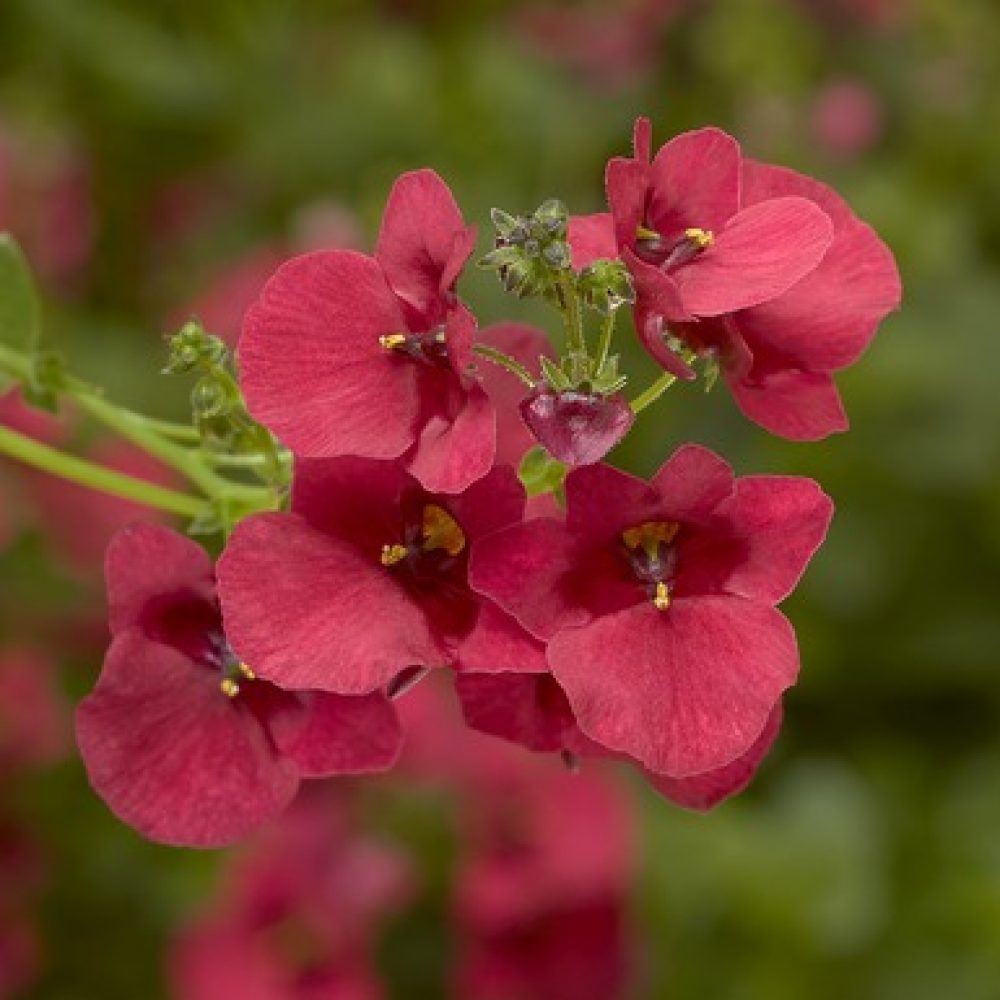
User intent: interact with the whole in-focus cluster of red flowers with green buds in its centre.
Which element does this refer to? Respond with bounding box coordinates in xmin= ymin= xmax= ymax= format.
xmin=70 ymin=120 xmax=900 ymax=845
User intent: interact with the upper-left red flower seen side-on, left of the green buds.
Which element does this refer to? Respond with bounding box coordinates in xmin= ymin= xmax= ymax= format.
xmin=239 ymin=170 xmax=495 ymax=493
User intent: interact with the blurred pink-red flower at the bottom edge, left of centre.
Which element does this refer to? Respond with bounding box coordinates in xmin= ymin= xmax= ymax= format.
xmin=170 ymin=796 xmax=411 ymax=1000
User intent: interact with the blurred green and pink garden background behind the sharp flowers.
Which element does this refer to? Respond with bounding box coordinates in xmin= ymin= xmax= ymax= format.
xmin=0 ymin=0 xmax=1000 ymax=1000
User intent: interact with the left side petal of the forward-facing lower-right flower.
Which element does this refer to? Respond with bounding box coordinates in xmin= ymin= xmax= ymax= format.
xmin=469 ymin=518 xmax=590 ymax=640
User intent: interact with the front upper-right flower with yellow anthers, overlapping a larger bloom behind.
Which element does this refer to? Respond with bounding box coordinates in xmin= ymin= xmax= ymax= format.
xmin=606 ymin=119 xmax=831 ymax=358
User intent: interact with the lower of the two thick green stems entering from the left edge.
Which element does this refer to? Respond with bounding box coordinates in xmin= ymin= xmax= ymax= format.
xmin=0 ymin=426 xmax=207 ymax=518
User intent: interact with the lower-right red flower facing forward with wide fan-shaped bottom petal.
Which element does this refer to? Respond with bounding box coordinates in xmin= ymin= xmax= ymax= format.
xmin=470 ymin=445 xmax=832 ymax=778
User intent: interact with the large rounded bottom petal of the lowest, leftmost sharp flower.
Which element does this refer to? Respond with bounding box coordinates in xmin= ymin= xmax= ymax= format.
xmin=76 ymin=630 xmax=298 ymax=847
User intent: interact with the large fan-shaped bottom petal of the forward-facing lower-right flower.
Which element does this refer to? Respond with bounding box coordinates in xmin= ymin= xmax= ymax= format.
xmin=548 ymin=597 xmax=799 ymax=778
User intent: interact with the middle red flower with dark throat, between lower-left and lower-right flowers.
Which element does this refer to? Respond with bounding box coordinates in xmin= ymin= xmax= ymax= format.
xmin=219 ymin=458 xmax=546 ymax=694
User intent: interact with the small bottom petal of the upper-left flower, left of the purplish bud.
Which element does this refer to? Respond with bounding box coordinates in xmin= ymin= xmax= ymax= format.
xmin=406 ymin=385 xmax=496 ymax=493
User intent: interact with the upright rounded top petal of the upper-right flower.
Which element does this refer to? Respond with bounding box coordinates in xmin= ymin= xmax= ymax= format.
xmin=646 ymin=128 xmax=740 ymax=238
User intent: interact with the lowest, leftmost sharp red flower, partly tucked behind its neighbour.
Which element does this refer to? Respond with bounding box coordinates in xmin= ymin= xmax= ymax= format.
xmin=77 ymin=525 xmax=401 ymax=847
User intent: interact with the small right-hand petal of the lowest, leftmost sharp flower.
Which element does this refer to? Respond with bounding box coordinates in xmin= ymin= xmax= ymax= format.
xmin=266 ymin=692 xmax=403 ymax=778
